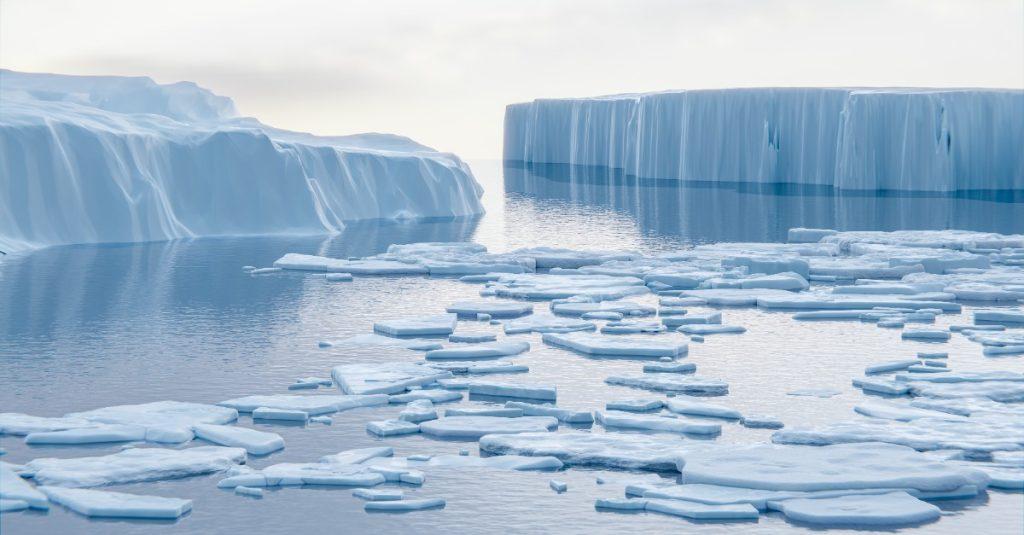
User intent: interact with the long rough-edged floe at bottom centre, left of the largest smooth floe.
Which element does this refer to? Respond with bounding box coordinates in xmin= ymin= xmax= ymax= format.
xmin=480 ymin=431 xmax=682 ymax=470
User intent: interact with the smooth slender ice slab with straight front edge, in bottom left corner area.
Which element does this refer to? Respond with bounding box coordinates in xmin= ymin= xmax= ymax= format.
xmin=39 ymin=486 xmax=191 ymax=519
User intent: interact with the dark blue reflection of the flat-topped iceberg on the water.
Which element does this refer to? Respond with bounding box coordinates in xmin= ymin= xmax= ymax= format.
xmin=504 ymin=157 xmax=1024 ymax=242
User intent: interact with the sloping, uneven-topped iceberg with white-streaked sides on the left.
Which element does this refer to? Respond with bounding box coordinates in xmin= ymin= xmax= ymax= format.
xmin=0 ymin=71 xmax=483 ymax=252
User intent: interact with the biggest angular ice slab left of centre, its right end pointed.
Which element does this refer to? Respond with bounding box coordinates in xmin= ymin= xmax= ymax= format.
xmin=331 ymin=362 xmax=452 ymax=395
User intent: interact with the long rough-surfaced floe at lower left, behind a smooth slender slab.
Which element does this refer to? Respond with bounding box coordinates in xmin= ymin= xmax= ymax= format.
xmin=26 ymin=446 xmax=246 ymax=487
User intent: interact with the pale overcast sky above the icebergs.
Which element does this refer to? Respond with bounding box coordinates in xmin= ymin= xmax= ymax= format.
xmin=0 ymin=0 xmax=1024 ymax=159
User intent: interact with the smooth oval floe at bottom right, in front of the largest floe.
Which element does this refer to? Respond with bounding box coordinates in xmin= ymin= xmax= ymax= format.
xmin=779 ymin=491 xmax=941 ymax=527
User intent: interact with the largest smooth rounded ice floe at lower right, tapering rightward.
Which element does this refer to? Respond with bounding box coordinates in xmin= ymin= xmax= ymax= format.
xmin=682 ymin=438 xmax=984 ymax=492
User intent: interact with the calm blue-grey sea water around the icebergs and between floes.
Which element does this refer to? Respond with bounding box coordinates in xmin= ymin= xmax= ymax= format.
xmin=0 ymin=162 xmax=1024 ymax=534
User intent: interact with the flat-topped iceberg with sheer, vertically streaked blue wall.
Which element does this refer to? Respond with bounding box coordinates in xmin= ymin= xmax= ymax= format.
xmin=505 ymin=88 xmax=1024 ymax=192
